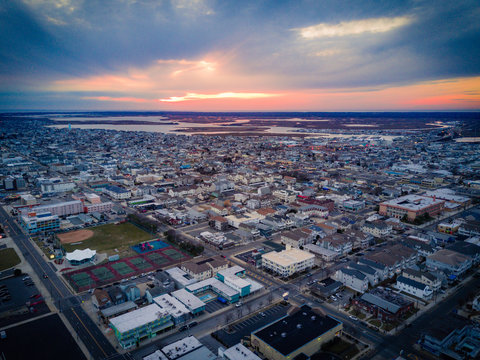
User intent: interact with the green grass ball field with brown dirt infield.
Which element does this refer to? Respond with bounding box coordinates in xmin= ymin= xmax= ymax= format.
xmin=63 ymin=222 xmax=152 ymax=257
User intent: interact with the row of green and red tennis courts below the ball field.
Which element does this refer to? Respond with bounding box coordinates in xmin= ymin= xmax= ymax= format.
xmin=63 ymin=246 xmax=190 ymax=292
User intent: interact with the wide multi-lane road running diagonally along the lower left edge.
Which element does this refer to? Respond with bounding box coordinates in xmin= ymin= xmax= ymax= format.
xmin=0 ymin=208 xmax=117 ymax=359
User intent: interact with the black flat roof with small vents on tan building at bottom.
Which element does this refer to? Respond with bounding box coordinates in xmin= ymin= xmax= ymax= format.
xmin=252 ymin=305 xmax=342 ymax=356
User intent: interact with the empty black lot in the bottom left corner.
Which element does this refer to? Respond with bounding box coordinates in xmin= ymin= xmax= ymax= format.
xmin=0 ymin=314 xmax=85 ymax=360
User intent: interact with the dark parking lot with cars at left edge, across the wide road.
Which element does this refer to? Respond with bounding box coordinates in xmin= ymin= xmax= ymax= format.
xmin=0 ymin=275 xmax=50 ymax=327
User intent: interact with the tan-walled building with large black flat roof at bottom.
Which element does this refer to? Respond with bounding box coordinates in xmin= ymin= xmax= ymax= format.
xmin=251 ymin=305 xmax=343 ymax=360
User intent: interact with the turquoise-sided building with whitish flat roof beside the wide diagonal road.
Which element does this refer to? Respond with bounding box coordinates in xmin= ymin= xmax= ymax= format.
xmin=109 ymin=304 xmax=174 ymax=349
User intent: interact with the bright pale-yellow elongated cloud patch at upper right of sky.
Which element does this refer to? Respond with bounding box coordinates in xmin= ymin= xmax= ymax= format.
xmin=294 ymin=16 xmax=412 ymax=39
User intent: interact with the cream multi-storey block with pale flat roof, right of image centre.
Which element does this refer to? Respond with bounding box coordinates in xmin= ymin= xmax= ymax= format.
xmin=262 ymin=245 xmax=315 ymax=277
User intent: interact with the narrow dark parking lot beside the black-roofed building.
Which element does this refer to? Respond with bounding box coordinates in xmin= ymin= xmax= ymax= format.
xmin=213 ymin=304 xmax=288 ymax=347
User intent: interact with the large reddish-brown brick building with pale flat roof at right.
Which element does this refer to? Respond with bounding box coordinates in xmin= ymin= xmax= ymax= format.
xmin=379 ymin=195 xmax=445 ymax=221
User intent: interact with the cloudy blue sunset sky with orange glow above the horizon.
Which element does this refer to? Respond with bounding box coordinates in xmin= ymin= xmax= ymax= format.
xmin=0 ymin=0 xmax=480 ymax=111
